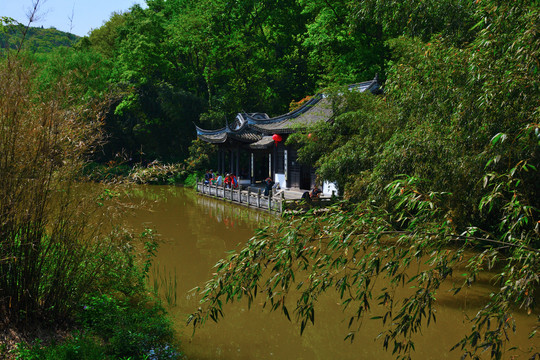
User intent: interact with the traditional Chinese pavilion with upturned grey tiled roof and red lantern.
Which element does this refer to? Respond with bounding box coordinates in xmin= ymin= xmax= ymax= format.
xmin=196 ymin=77 xmax=381 ymax=195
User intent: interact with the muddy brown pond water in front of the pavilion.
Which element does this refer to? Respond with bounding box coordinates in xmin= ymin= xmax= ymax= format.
xmin=127 ymin=186 xmax=539 ymax=360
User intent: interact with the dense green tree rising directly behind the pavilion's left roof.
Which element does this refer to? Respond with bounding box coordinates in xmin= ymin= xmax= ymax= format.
xmin=167 ymin=0 xmax=312 ymax=114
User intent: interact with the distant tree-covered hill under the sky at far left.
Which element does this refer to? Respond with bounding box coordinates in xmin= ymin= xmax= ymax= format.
xmin=0 ymin=25 xmax=79 ymax=53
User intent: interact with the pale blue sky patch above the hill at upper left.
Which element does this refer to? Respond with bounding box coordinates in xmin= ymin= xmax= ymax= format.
xmin=0 ymin=0 xmax=146 ymax=36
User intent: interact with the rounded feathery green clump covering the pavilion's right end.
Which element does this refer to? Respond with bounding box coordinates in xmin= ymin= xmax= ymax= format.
xmin=288 ymin=89 xmax=401 ymax=197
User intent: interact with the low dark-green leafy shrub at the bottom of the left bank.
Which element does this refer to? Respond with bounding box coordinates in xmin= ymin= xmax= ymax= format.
xmin=14 ymin=294 xmax=181 ymax=360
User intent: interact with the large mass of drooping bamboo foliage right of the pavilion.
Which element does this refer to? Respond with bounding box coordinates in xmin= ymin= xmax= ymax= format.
xmin=290 ymin=2 xmax=540 ymax=228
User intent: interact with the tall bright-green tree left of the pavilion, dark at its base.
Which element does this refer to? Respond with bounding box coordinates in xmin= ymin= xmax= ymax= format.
xmin=89 ymin=2 xmax=206 ymax=162
